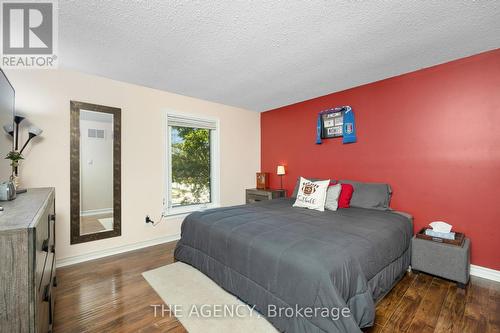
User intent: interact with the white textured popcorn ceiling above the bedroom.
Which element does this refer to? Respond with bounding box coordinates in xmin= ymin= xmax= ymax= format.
xmin=59 ymin=0 xmax=500 ymax=111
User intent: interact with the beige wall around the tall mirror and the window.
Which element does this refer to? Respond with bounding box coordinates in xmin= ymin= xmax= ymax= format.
xmin=6 ymin=70 xmax=260 ymax=259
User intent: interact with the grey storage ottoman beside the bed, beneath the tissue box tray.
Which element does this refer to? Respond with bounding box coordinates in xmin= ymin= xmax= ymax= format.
xmin=411 ymin=236 xmax=470 ymax=288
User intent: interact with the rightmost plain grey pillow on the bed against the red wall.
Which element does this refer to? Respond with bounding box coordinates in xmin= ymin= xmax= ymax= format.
xmin=340 ymin=180 xmax=392 ymax=210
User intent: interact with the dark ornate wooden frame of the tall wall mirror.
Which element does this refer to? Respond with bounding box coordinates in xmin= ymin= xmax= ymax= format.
xmin=70 ymin=101 xmax=122 ymax=244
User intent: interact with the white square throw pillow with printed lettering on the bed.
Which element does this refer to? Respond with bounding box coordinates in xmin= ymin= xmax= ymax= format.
xmin=293 ymin=177 xmax=330 ymax=212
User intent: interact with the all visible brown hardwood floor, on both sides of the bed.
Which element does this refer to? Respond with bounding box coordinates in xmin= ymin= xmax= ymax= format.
xmin=54 ymin=243 xmax=500 ymax=333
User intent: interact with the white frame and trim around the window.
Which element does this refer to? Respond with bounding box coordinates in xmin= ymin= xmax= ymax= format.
xmin=163 ymin=110 xmax=220 ymax=216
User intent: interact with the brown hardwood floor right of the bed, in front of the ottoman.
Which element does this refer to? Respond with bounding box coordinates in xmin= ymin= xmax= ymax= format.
xmin=365 ymin=273 xmax=500 ymax=333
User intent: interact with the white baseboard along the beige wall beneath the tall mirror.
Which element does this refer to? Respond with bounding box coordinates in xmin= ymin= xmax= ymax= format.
xmin=56 ymin=234 xmax=180 ymax=267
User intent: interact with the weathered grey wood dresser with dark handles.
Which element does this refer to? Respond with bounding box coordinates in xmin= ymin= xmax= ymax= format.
xmin=0 ymin=188 xmax=57 ymax=333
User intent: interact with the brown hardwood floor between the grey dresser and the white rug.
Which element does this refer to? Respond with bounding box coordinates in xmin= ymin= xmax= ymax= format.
xmin=54 ymin=243 xmax=186 ymax=333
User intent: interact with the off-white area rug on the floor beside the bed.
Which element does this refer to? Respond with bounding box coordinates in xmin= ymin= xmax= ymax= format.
xmin=142 ymin=262 xmax=278 ymax=333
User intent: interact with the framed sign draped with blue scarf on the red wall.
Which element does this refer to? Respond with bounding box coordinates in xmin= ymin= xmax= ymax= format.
xmin=316 ymin=106 xmax=356 ymax=144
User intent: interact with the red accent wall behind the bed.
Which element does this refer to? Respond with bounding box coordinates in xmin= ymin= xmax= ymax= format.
xmin=261 ymin=49 xmax=500 ymax=270
